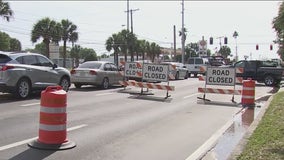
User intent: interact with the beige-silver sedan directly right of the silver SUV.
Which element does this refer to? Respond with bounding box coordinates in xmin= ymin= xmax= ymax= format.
xmin=70 ymin=61 xmax=123 ymax=89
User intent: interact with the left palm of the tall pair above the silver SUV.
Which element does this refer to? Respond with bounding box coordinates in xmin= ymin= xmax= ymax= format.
xmin=31 ymin=18 xmax=61 ymax=58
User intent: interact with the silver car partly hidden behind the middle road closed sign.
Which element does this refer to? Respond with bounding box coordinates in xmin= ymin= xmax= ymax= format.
xmin=161 ymin=62 xmax=189 ymax=80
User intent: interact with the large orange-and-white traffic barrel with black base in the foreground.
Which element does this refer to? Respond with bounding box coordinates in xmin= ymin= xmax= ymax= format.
xmin=28 ymin=86 xmax=76 ymax=150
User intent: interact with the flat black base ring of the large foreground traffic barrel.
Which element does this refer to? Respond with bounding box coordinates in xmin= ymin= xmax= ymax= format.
xmin=28 ymin=140 xmax=76 ymax=150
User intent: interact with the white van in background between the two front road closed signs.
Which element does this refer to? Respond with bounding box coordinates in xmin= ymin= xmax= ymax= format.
xmin=184 ymin=57 xmax=208 ymax=77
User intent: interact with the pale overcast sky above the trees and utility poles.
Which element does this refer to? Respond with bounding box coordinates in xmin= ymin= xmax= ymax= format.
xmin=0 ymin=0 xmax=281 ymax=59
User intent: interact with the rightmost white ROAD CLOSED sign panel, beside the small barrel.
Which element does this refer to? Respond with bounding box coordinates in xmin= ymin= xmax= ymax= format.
xmin=206 ymin=67 xmax=236 ymax=86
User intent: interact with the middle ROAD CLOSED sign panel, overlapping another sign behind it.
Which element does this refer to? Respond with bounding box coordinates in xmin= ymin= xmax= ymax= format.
xmin=143 ymin=63 xmax=169 ymax=82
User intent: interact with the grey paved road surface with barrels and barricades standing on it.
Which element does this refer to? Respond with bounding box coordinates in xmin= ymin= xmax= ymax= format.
xmin=0 ymin=78 xmax=271 ymax=160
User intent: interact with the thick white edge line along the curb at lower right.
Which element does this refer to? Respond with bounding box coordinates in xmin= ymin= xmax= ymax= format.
xmin=185 ymin=120 xmax=234 ymax=160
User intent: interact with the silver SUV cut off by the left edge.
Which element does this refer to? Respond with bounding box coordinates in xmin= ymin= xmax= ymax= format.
xmin=0 ymin=51 xmax=70 ymax=98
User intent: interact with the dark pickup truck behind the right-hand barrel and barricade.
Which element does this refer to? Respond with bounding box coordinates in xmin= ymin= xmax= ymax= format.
xmin=234 ymin=60 xmax=284 ymax=86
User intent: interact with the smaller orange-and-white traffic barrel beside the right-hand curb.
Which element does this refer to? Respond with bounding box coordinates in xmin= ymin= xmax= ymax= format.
xmin=242 ymin=79 xmax=255 ymax=107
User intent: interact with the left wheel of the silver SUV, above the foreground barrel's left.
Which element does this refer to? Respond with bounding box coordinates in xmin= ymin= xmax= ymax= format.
xmin=15 ymin=78 xmax=31 ymax=99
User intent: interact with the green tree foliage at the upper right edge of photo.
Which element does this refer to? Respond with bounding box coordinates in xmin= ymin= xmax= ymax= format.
xmin=272 ymin=2 xmax=284 ymax=60
